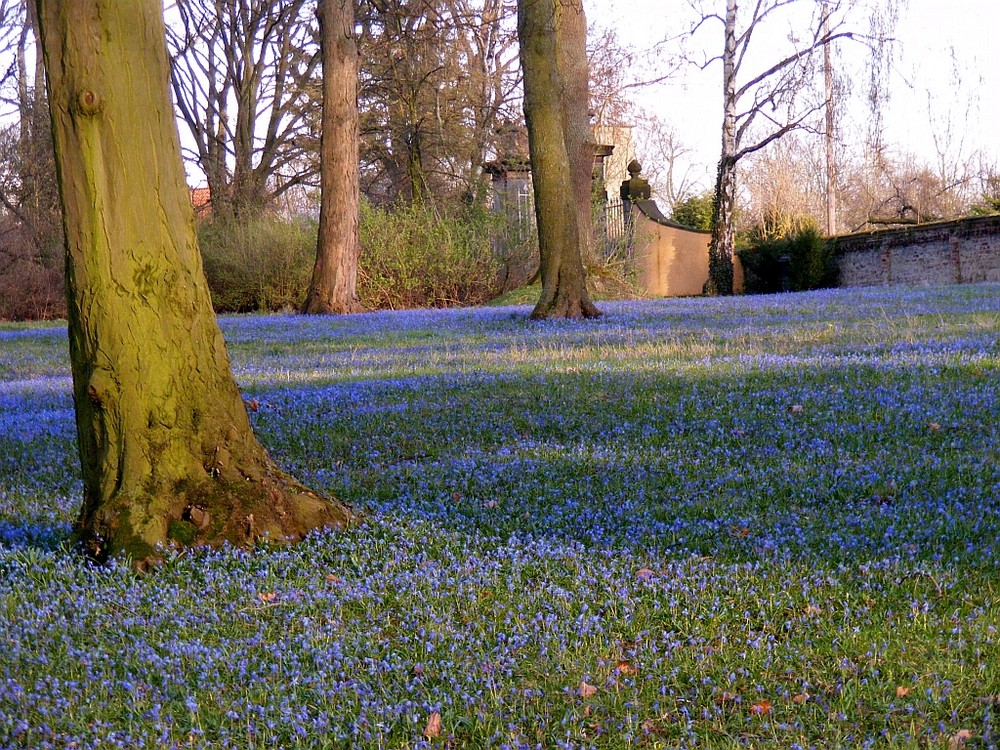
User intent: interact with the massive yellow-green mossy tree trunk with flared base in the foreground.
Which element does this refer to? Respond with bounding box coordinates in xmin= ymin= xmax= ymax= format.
xmin=38 ymin=0 xmax=351 ymax=565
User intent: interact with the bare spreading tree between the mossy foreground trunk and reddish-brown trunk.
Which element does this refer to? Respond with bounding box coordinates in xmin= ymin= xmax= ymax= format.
xmin=167 ymin=0 xmax=320 ymax=216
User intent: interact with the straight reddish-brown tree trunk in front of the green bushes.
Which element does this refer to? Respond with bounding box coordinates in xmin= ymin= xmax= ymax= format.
xmin=302 ymin=0 xmax=370 ymax=314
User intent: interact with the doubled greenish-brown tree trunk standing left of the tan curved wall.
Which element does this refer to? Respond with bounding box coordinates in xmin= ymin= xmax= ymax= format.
xmin=518 ymin=0 xmax=601 ymax=318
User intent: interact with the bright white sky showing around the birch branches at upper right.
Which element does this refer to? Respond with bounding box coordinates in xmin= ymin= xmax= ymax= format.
xmin=584 ymin=0 xmax=1000 ymax=197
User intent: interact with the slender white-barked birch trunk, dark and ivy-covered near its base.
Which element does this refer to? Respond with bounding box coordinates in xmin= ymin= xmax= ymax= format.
xmin=705 ymin=0 xmax=737 ymax=295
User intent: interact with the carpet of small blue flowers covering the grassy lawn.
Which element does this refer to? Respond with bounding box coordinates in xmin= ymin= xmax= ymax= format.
xmin=0 ymin=285 xmax=1000 ymax=749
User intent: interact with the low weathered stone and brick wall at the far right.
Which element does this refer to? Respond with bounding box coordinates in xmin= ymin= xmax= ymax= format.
xmin=834 ymin=216 xmax=1000 ymax=286
